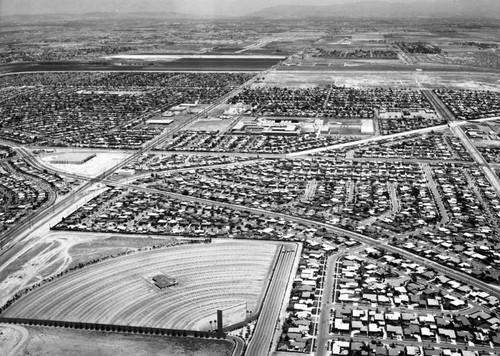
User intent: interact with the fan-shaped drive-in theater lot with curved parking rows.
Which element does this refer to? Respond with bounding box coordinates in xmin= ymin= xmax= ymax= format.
xmin=2 ymin=241 xmax=279 ymax=330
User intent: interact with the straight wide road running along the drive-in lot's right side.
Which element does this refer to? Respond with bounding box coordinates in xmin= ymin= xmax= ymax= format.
xmin=246 ymin=245 xmax=298 ymax=356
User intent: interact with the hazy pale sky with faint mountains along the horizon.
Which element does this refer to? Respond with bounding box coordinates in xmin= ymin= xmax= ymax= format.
xmin=0 ymin=0 xmax=500 ymax=19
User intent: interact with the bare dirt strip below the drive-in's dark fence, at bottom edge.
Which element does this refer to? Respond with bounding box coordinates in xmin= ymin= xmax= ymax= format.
xmin=19 ymin=327 xmax=233 ymax=356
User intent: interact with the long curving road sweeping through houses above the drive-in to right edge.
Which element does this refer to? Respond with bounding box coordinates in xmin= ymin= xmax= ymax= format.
xmin=114 ymin=183 xmax=500 ymax=299
